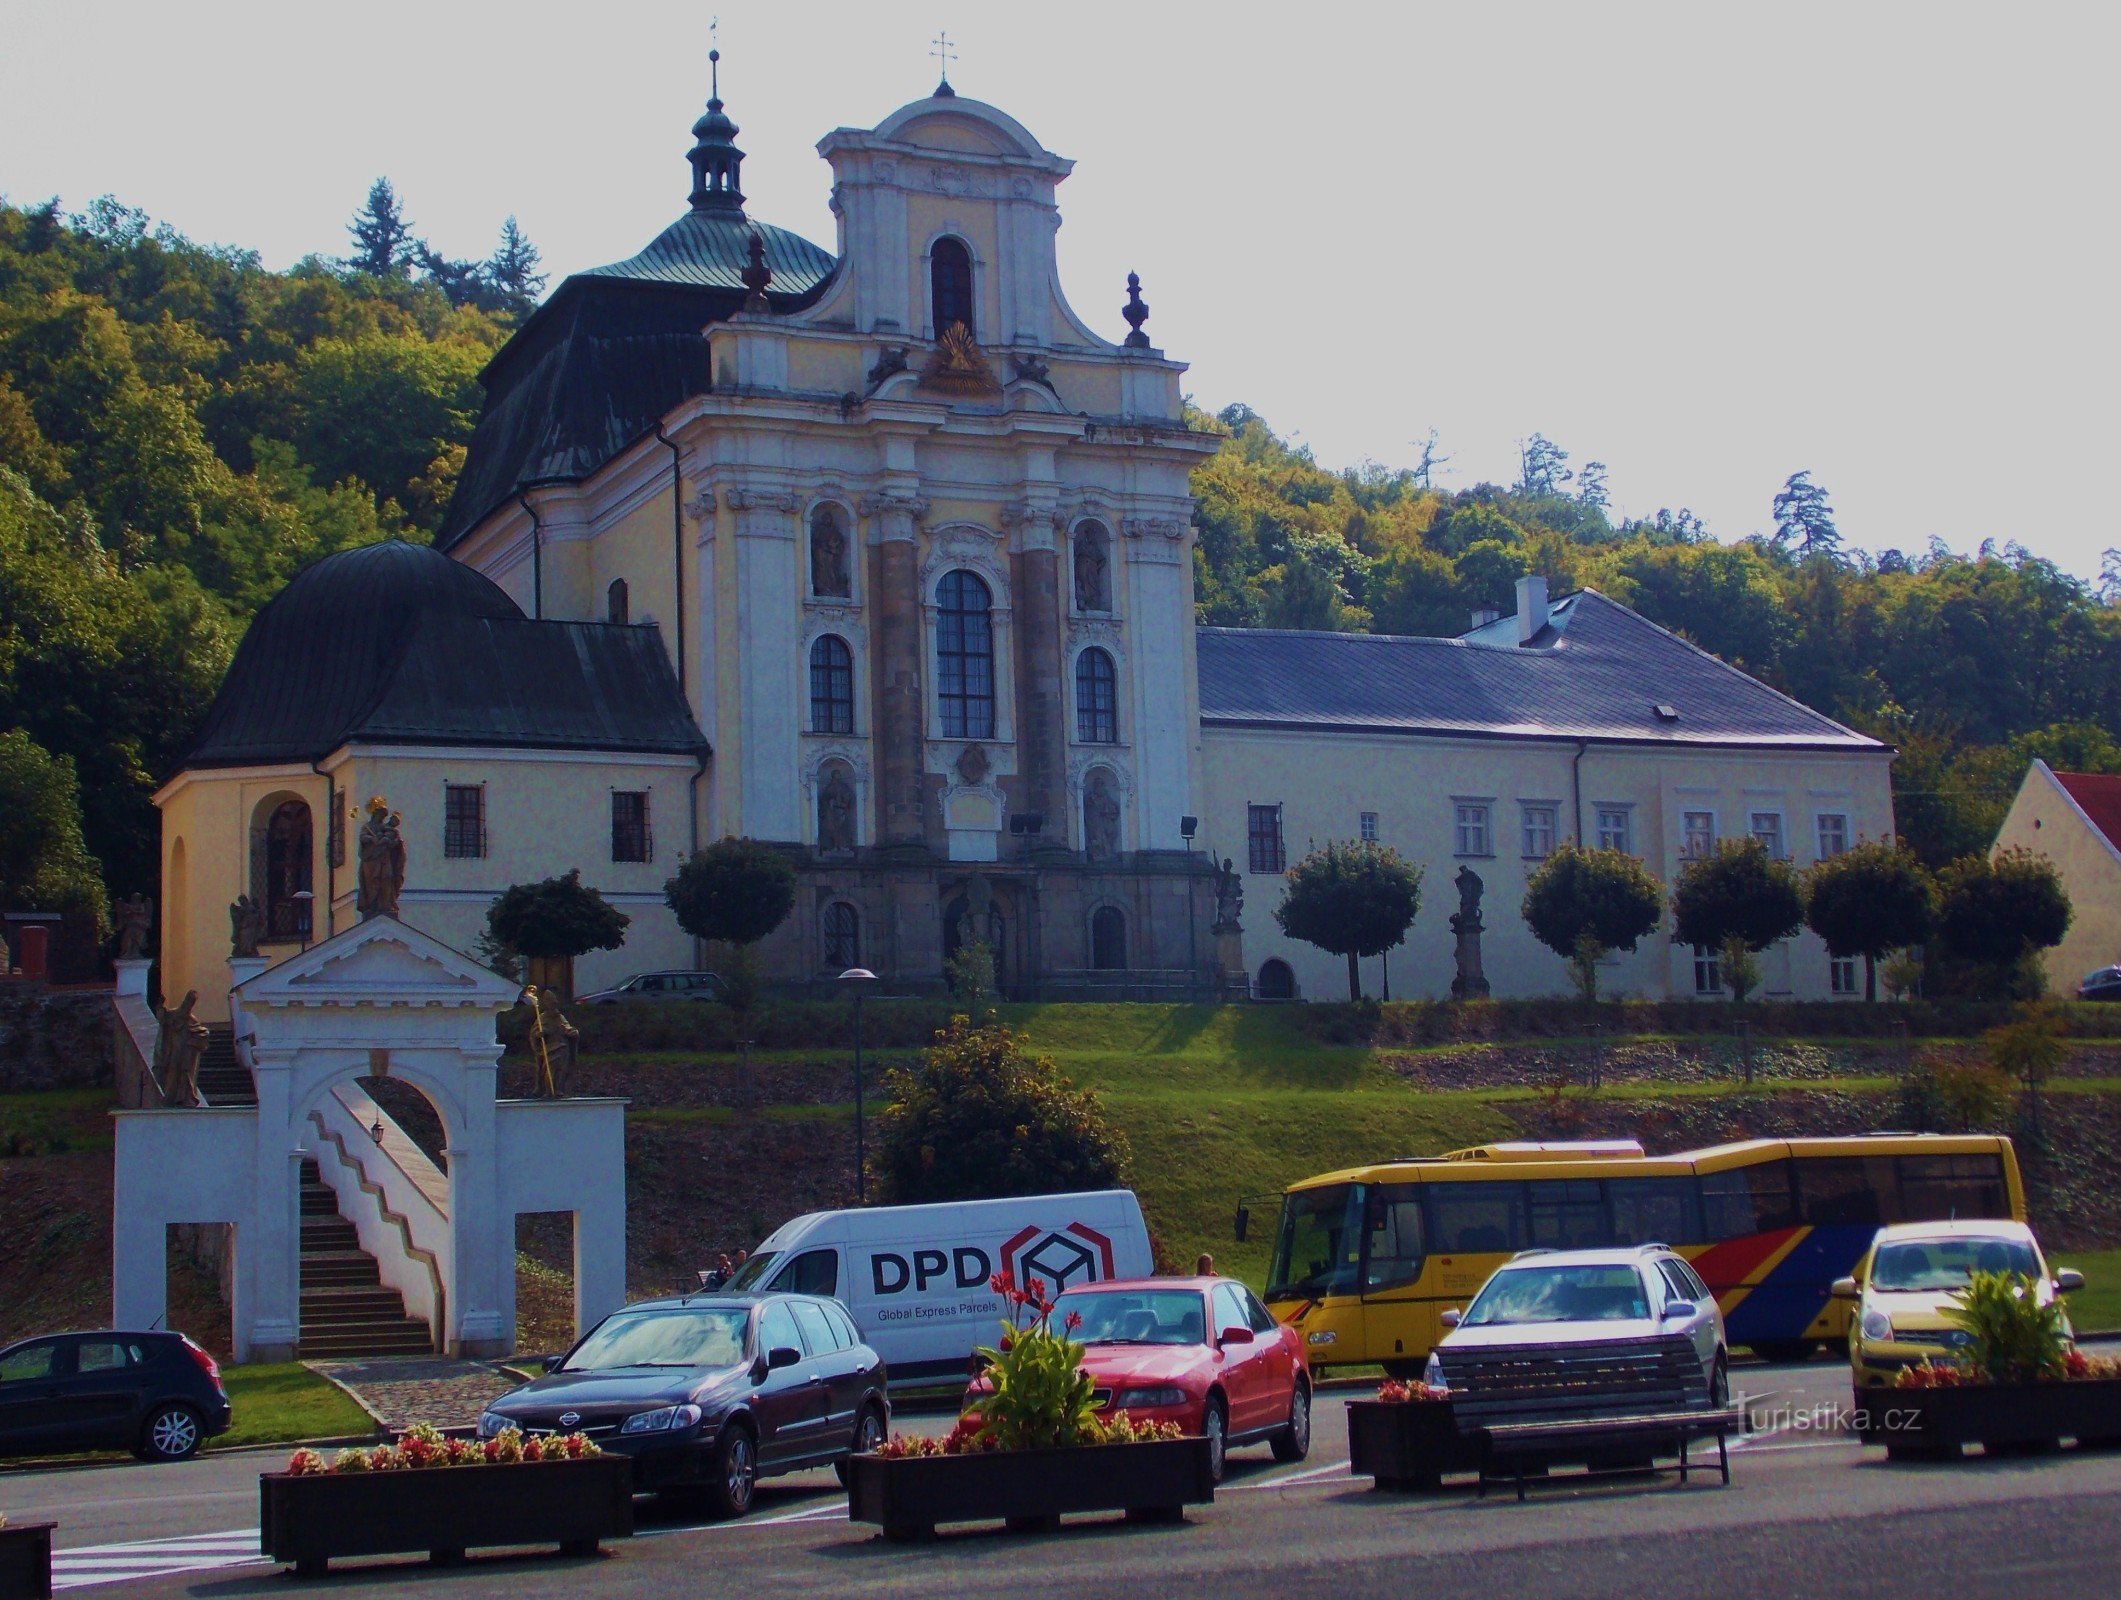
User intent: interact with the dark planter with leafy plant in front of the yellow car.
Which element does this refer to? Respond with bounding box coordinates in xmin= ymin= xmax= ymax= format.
xmin=1856 ymin=1273 xmax=2121 ymax=1460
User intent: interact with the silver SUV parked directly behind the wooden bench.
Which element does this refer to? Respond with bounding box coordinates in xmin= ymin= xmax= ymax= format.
xmin=1423 ymin=1244 xmax=1731 ymax=1409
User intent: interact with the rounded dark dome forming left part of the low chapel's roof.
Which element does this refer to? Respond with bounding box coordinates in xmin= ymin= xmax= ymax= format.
xmin=185 ymin=539 xmax=524 ymax=766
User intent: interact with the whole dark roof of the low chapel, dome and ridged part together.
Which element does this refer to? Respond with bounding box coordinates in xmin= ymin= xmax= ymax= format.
xmin=182 ymin=539 xmax=706 ymax=768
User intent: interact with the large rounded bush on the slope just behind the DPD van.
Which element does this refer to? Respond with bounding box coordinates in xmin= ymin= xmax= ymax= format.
xmin=870 ymin=1016 xmax=1130 ymax=1205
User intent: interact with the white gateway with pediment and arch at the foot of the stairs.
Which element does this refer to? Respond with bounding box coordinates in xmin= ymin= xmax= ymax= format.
xmin=112 ymin=917 xmax=626 ymax=1362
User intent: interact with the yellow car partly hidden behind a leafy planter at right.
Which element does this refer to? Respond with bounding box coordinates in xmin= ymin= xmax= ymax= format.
xmin=1835 ymin=1222 xmax=2085 ymax=1390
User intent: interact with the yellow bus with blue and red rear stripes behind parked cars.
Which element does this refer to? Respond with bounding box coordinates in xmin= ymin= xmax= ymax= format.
xmin=1239 ymin=1133 xmax=2026 ymax=1375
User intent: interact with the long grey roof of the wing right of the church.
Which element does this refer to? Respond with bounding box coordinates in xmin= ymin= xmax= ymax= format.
xmin=1198 ymin=590 xmax=1886 ymax=751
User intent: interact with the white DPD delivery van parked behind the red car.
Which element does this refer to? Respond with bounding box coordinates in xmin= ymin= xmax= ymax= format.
xmin=730 ymin=1188 xmax=1156 ymax=1388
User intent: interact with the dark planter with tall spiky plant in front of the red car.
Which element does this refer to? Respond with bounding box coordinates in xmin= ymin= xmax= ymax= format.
xmin=846 ymin=1273 xmax=1215 ymax=1538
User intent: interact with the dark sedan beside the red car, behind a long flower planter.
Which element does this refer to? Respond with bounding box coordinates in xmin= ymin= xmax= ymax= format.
xmin=479 ymin=1294 xmax=891 ymax=1517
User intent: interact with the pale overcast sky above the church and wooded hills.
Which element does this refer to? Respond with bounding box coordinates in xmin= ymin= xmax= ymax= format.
xmin=0 ymin=0 xmax=2121 ymax=577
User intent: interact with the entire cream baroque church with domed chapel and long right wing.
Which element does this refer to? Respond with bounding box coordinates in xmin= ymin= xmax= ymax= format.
xmin=157 ymin=71 xmax=1892 ymax=1014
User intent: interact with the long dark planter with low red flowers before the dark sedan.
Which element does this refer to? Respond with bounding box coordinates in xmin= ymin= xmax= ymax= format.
xmin=259 ymin=1426 xmax=634 ymax=1575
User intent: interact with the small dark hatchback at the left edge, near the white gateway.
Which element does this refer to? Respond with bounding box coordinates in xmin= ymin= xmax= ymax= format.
xmin=0 ymin=1333 xmax=229 ymax=1462
